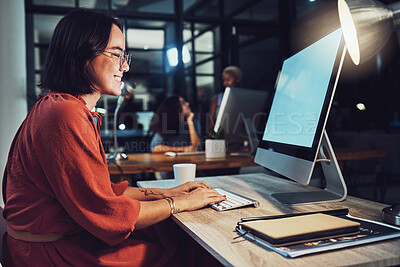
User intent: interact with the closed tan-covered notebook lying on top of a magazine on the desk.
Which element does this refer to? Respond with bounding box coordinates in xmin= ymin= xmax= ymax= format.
xmin=240 ymin=213 xmax=360 ymax=246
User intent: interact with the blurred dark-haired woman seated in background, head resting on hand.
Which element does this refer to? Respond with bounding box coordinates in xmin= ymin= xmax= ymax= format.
xmin=150 ymin=96 xmax=201 ymax=153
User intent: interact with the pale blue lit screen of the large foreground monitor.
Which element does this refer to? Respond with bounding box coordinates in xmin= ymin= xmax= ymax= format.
xmin=262 ymin=30 xmax=341 ymax=148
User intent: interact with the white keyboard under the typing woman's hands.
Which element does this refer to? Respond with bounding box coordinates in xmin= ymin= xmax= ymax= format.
xmin=210 ymin=188 xmax=260 ymax=211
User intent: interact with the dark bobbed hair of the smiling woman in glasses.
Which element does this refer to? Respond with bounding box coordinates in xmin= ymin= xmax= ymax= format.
xmin=39 ymin=9 xmax=122 ymax=95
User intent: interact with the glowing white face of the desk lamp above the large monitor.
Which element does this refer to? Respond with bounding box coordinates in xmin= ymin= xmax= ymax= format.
xmin=338 ymin=0 xmax=360 ymax=65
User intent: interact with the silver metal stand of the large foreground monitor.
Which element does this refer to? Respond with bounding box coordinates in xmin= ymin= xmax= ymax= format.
xmin=272 ymin=130 xmax=347 ymax=205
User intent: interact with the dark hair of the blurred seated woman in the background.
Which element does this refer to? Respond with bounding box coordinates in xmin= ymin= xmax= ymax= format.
xmin=150 ymin=96 xmax=182 ymax=137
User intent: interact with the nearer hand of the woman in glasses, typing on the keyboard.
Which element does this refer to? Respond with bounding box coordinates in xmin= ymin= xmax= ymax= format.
xmin=174 ymin=188 xmax=226 ymax=212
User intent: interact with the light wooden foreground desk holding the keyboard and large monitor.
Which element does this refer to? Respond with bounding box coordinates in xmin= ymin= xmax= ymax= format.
xmin=138 ymin=174 xmax=400 ymax=266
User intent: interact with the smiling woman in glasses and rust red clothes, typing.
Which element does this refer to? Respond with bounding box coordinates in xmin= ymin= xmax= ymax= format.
xmin=3 ymin=10 xmax=223 ymax=266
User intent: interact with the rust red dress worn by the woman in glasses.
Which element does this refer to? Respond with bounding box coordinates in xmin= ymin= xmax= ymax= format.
xmin=3 ymin=93 xmax=176 ymax=266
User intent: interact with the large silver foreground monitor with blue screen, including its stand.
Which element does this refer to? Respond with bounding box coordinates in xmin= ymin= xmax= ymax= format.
xmin=255 ymin=29 xmax=347 ymax=204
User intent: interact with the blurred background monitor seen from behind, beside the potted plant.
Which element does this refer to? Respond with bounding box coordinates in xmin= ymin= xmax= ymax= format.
xmin=214 ymin=87 xmax=268 ymax=153
